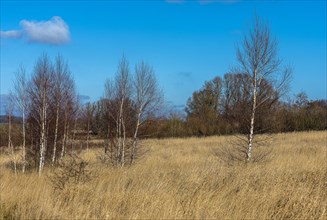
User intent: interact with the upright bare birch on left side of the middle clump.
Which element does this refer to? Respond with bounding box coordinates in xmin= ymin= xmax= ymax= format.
xmin=104 ymin=55 xmax=132 ymax=167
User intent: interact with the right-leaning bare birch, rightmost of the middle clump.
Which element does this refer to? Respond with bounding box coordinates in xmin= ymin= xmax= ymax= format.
xmin=130 ymin=61 xmax=163 ymax=164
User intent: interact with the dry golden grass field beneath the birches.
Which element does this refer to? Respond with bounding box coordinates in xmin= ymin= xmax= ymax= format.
xmin=0 ymin=131 xmax=327 ymax=219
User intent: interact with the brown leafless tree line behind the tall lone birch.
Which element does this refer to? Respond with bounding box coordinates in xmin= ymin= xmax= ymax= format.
xmin=153 ymin=79 xmax=327 ymax=138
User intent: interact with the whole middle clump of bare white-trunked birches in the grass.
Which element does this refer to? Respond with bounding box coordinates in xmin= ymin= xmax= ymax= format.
xmin=101 ymin=56 xmax=163 ymax=167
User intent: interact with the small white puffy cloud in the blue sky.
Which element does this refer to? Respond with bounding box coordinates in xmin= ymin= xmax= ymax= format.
xmin=0 ymin=16 xmax=70 ymax=45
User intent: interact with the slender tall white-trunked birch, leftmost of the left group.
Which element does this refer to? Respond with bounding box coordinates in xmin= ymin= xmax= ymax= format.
xmin=12 ymin=65 xmax=28 ymax=173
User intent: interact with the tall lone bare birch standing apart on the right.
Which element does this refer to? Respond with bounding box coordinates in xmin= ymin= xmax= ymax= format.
xmin=237 ymin=17 xmax=291 ymax=161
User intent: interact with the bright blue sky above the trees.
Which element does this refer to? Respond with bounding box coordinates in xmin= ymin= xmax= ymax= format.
xmin=0 ymin=0 xmax=327 ymax=109
